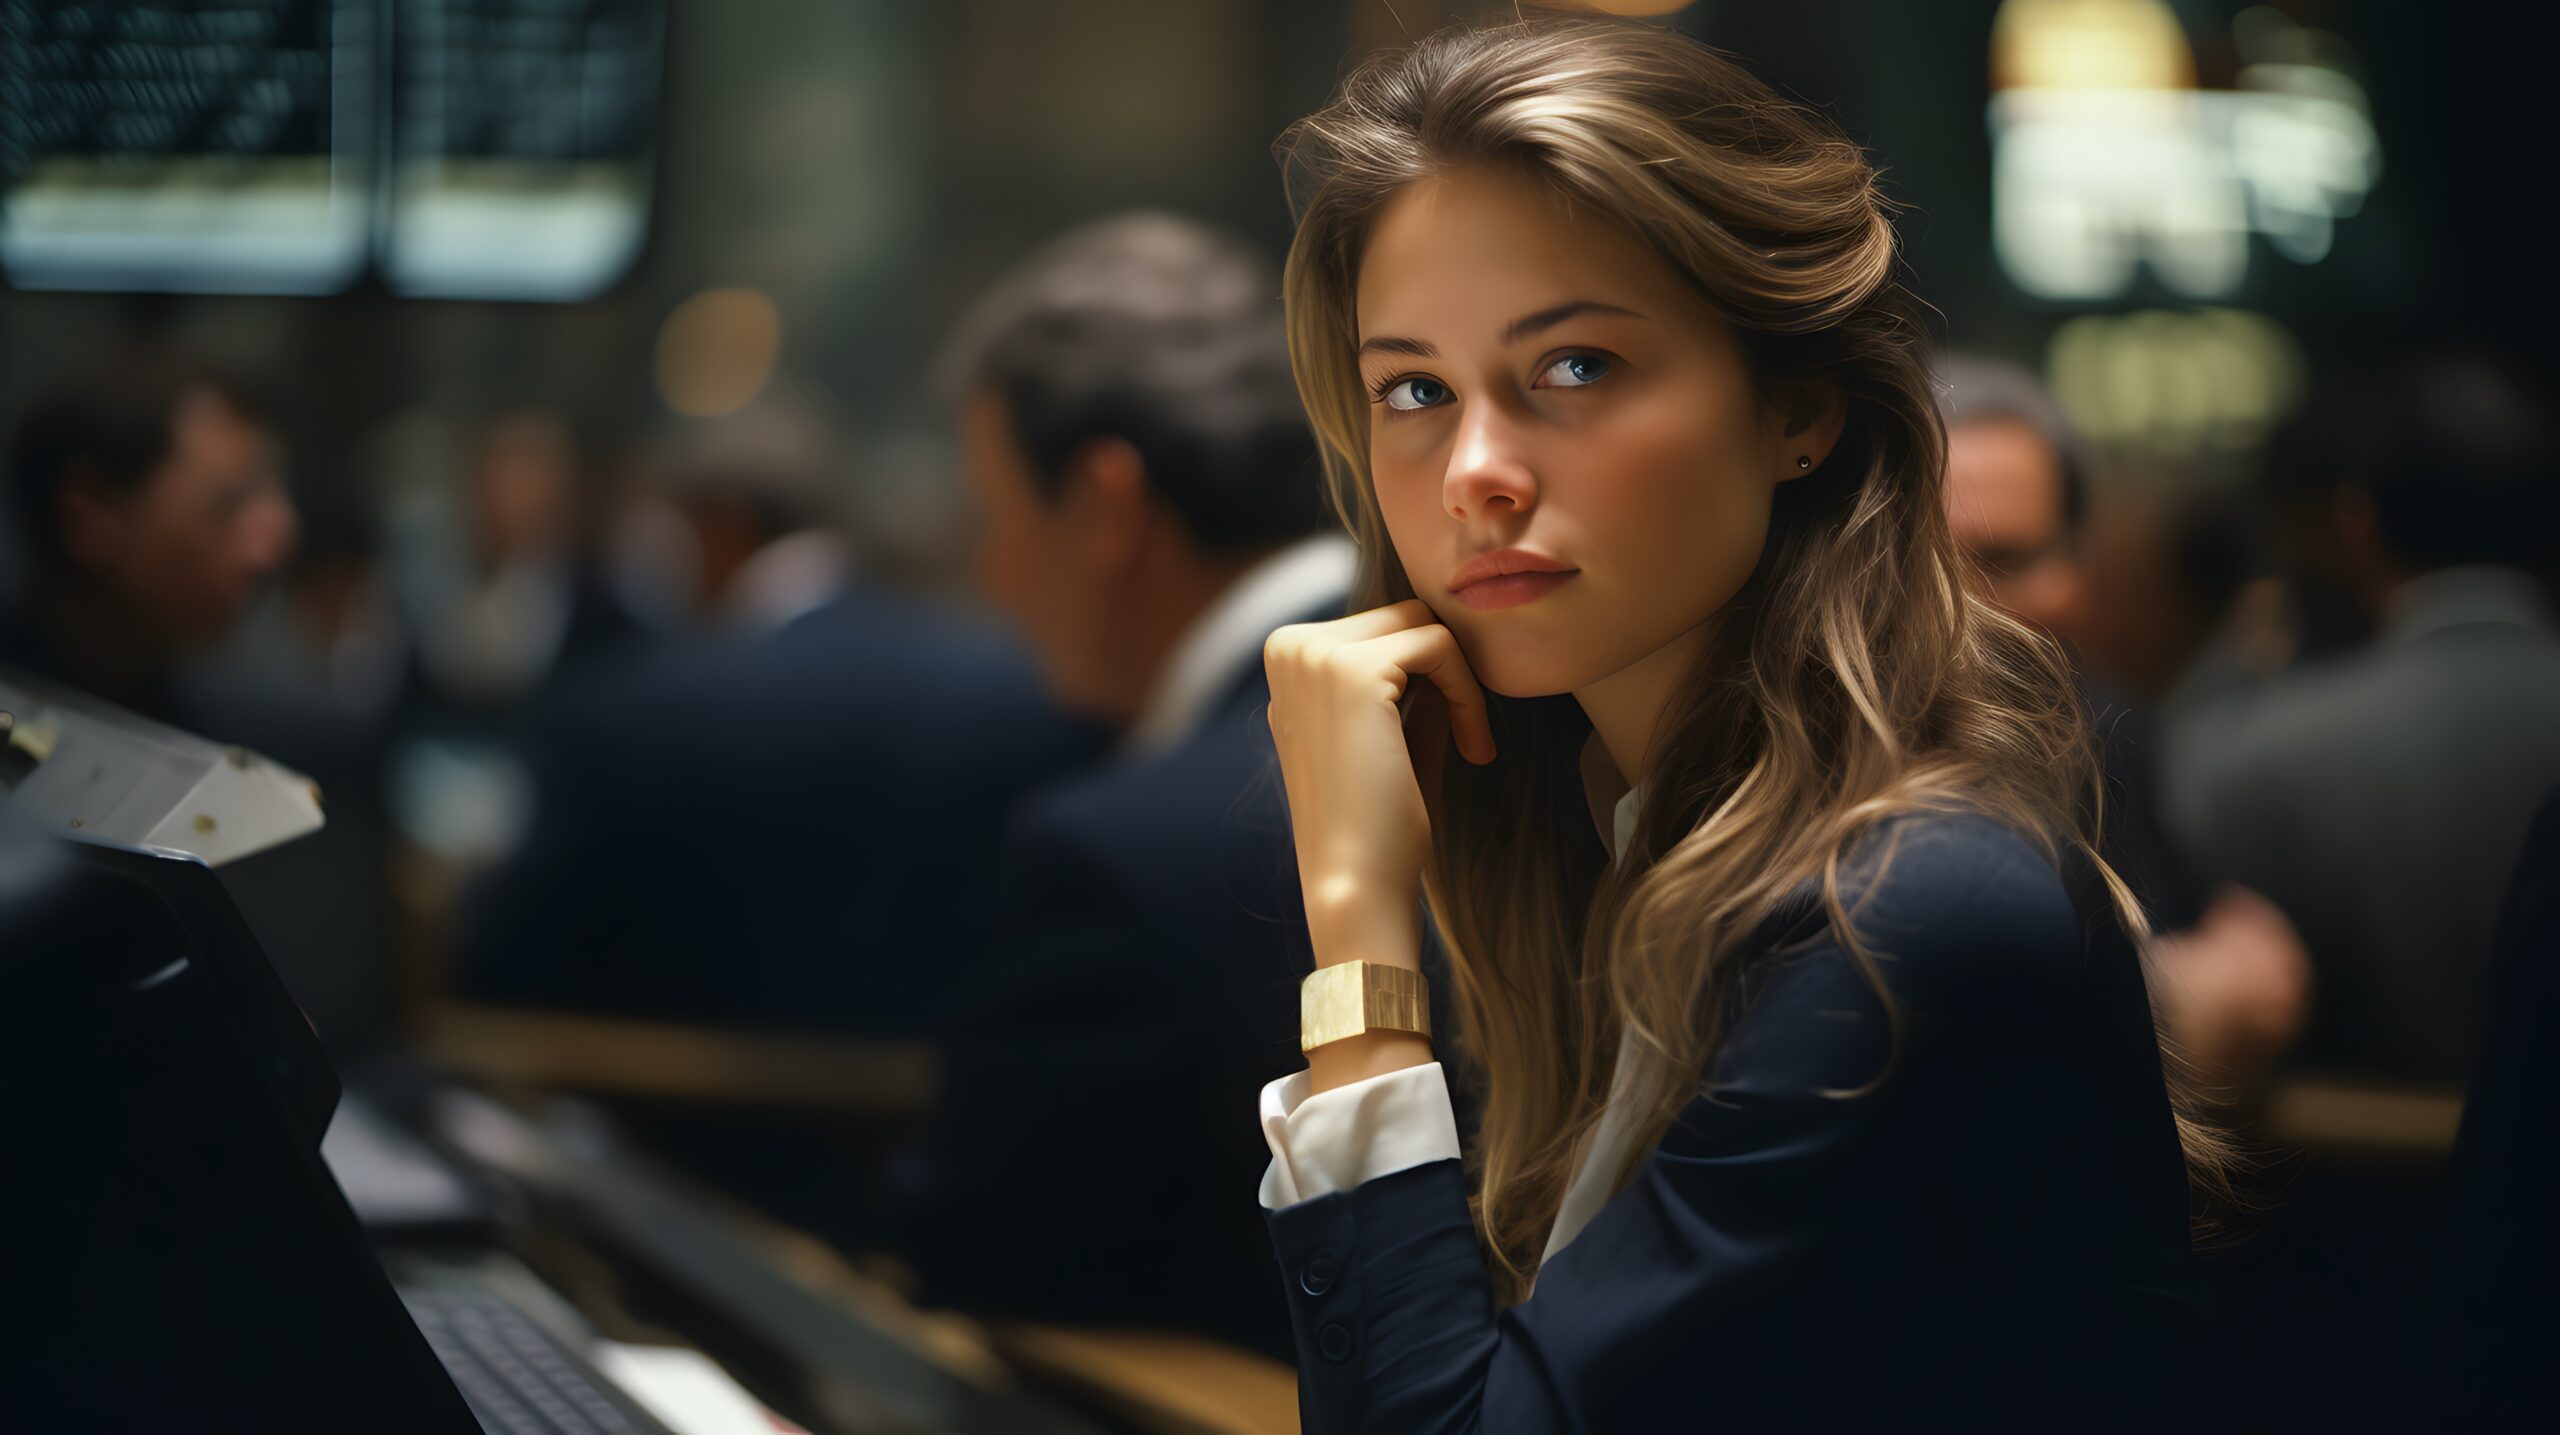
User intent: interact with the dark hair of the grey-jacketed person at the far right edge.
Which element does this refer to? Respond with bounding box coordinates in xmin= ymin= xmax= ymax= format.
xmin=2350 ymin=356 xmax=2560 ymax=570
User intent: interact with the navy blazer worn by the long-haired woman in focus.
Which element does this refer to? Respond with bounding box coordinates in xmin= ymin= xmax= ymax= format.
xmin=1267 ymin=816 xmax=2189 ymax=1435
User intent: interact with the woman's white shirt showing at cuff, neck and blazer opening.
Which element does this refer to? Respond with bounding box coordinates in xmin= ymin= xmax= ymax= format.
xmin=1262 ymin=737 xmax=1644 ymax=1264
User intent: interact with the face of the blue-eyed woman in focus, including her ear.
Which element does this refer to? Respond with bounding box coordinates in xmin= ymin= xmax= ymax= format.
xmin=1357 ymin=171 xmax=1838 ymax=696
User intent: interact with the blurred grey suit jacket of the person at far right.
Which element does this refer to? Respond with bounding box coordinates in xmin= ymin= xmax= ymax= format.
xmin=2168 ymin=568 xmax=2560 ymax=1090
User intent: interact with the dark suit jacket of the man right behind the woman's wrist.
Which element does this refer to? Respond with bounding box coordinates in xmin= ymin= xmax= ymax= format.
xmin=909 ymin=644 xmax=1329 ymax=1351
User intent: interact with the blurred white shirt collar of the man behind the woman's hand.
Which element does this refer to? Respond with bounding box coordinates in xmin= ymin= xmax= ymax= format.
xmin=1121 ymin=532 xmax=1359 ymax=757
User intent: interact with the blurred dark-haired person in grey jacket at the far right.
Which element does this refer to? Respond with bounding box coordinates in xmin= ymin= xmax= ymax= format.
xmin=2168 ymin=358 xmax=2560 ymax=1087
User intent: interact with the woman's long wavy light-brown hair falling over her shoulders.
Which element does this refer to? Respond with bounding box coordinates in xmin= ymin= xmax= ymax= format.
xmin=1277 ymin=20 xmax=2225 ymax=1299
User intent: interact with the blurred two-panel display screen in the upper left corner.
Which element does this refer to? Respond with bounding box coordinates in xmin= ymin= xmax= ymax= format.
xmin=0 ymin=0 xmax=666 ymax=299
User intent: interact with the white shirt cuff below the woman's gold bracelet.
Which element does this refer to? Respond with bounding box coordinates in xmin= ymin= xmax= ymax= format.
xmin=1262 ymin=1062 xmax=1459 ymax=1210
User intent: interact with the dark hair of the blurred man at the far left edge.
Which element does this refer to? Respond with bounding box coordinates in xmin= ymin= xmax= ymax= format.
xmin=8 ymin=348 xmax=271 ymax=563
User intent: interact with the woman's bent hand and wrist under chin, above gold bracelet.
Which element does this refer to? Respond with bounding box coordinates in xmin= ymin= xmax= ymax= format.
xmin=1262 ymin=599 xmax=1492 ymax=967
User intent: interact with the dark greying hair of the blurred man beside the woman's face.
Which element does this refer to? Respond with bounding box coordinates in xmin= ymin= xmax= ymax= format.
xmin=947 ymin=215 xmax=1326 ymax=553
